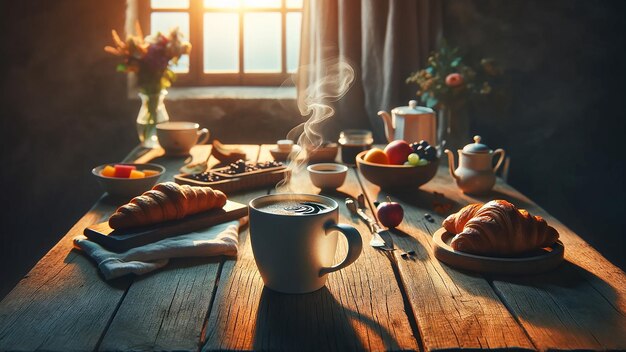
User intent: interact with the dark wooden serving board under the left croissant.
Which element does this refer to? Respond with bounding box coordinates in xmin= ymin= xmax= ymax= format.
xmin=83 ymin=200 xmax=248 ymax=252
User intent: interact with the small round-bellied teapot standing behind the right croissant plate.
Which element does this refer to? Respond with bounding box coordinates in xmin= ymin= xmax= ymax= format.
xmin=445 ymin=136 xmax=505 ymax=194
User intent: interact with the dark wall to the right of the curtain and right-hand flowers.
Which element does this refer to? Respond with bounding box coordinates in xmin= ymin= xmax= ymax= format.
xmin=444 ymin=0 xmax=626 ymax=268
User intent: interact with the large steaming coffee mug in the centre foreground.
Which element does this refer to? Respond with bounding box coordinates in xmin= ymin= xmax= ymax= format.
xmin=248 ymin=194 xmax=363 ymax=293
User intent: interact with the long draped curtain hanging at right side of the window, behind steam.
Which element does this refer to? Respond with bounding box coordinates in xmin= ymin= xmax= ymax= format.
xmin=296 ymin=0 xmax=441 ymax=143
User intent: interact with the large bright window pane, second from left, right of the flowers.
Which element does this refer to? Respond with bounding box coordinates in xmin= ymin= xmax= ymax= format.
xmin=203 ymin=12 xmax=239 ymax=72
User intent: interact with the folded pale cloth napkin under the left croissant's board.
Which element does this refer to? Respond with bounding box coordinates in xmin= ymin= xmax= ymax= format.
xmin=74 ymin=220 xmax=242 ymax=280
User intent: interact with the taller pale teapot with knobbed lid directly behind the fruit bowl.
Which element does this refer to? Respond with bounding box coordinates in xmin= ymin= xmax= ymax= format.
xmin=378 ymin=100 xmax=437 ymax=145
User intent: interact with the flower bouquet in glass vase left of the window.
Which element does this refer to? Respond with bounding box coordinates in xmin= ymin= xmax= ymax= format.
xmin=104 ymin=24 xmax=191 ymax=148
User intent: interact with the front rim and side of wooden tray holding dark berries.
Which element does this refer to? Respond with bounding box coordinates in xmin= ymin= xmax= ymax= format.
xmin=174 ymin=167 xmax=289 ymax=194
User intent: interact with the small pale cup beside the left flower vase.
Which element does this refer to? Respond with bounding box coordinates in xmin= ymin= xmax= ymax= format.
xmin=157 ymin=121 xmax=209 ymax=155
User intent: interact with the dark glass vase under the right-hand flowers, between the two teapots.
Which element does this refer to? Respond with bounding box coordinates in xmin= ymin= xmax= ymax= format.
xmin=437 ymin=106 xmax=471 ymax=151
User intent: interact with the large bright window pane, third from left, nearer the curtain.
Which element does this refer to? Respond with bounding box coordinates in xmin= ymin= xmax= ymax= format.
xmin=243 ymin=12 xmax=281 ymax=72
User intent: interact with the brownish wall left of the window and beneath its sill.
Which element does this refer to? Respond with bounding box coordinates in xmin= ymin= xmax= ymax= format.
xmin=0 ymin=0 xmax=302 ymax=297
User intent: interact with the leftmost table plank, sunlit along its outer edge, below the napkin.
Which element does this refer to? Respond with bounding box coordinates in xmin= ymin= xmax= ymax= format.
xmin=0 ymin=200 xmax=130 ymax=351
